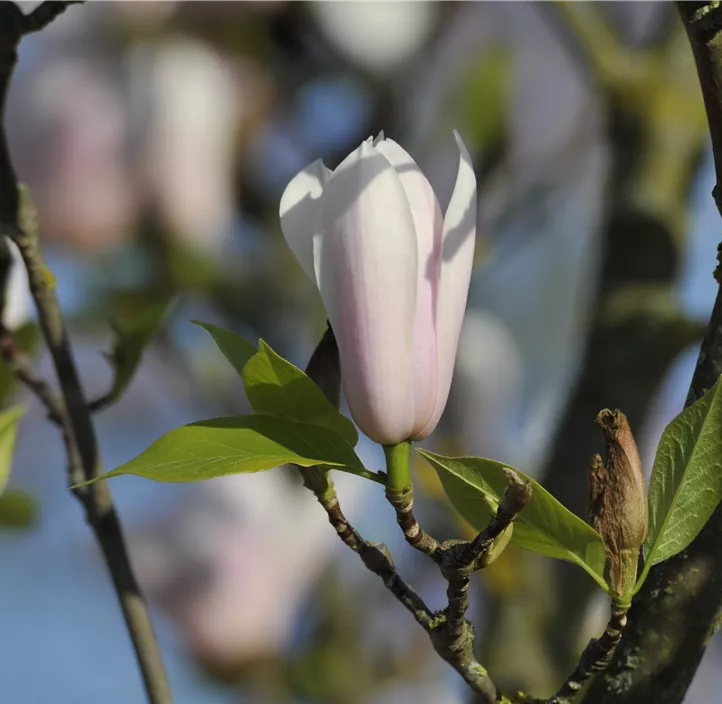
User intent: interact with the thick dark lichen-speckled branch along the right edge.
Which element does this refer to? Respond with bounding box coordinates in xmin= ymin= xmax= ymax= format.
xmin=583 ymin=0 xmax=722 ymax=704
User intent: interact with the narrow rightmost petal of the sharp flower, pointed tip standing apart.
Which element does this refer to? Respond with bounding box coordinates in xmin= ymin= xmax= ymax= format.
xmin=416 ymin=131 xmax=477 ymax=438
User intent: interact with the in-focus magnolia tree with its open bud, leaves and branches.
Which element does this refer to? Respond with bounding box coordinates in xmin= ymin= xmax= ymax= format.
xmin=0 ymin=0 xmax=722 ymax=704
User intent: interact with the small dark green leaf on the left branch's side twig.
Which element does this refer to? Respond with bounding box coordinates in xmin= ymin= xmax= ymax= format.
xmin=102 ymin=301 xmax=173 ymax=407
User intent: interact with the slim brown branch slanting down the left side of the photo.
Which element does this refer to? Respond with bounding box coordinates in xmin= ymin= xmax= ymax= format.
xmin=0 ymin=0 xmax=172 ymax=704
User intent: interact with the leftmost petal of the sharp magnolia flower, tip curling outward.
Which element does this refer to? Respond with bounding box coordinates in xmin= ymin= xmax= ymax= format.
xmin=279 ymin=159 xmax=331 ymax=281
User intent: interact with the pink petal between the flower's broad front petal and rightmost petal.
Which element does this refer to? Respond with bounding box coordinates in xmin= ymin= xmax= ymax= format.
xmin=376 ymin=133 xmax=443 ymax=437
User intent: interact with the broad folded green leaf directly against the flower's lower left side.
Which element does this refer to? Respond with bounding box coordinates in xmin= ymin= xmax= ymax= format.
xmin=243 ymin=340 xmax=358 ymax=447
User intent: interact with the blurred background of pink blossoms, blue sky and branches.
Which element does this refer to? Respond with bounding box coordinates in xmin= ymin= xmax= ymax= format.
xmin=0 ymin=0 xmax=722 ymax=704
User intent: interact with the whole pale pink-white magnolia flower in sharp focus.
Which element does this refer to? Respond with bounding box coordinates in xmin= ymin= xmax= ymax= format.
xmin=280 ymin=134 xmax=476 ymax=445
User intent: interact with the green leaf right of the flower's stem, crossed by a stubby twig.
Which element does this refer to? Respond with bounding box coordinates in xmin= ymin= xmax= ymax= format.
xmin=417 ymin=450 xmax=609 ymax=591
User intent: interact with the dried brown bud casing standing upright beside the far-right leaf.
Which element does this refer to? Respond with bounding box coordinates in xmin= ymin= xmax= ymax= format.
xmin=589 ymin=409 xmax=648 ymax=594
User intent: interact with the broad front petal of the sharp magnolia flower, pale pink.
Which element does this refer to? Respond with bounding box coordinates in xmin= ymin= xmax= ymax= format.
xmin=316 ymin=142 xmax=417 ymax=444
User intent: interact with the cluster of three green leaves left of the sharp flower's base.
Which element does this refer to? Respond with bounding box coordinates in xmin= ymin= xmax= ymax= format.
xmin=94 ymin=322 xmax=374 ymax=482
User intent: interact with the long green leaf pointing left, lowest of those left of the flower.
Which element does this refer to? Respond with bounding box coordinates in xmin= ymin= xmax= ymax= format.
xmin=81 ymin=415 xmax=370 ymax=483
